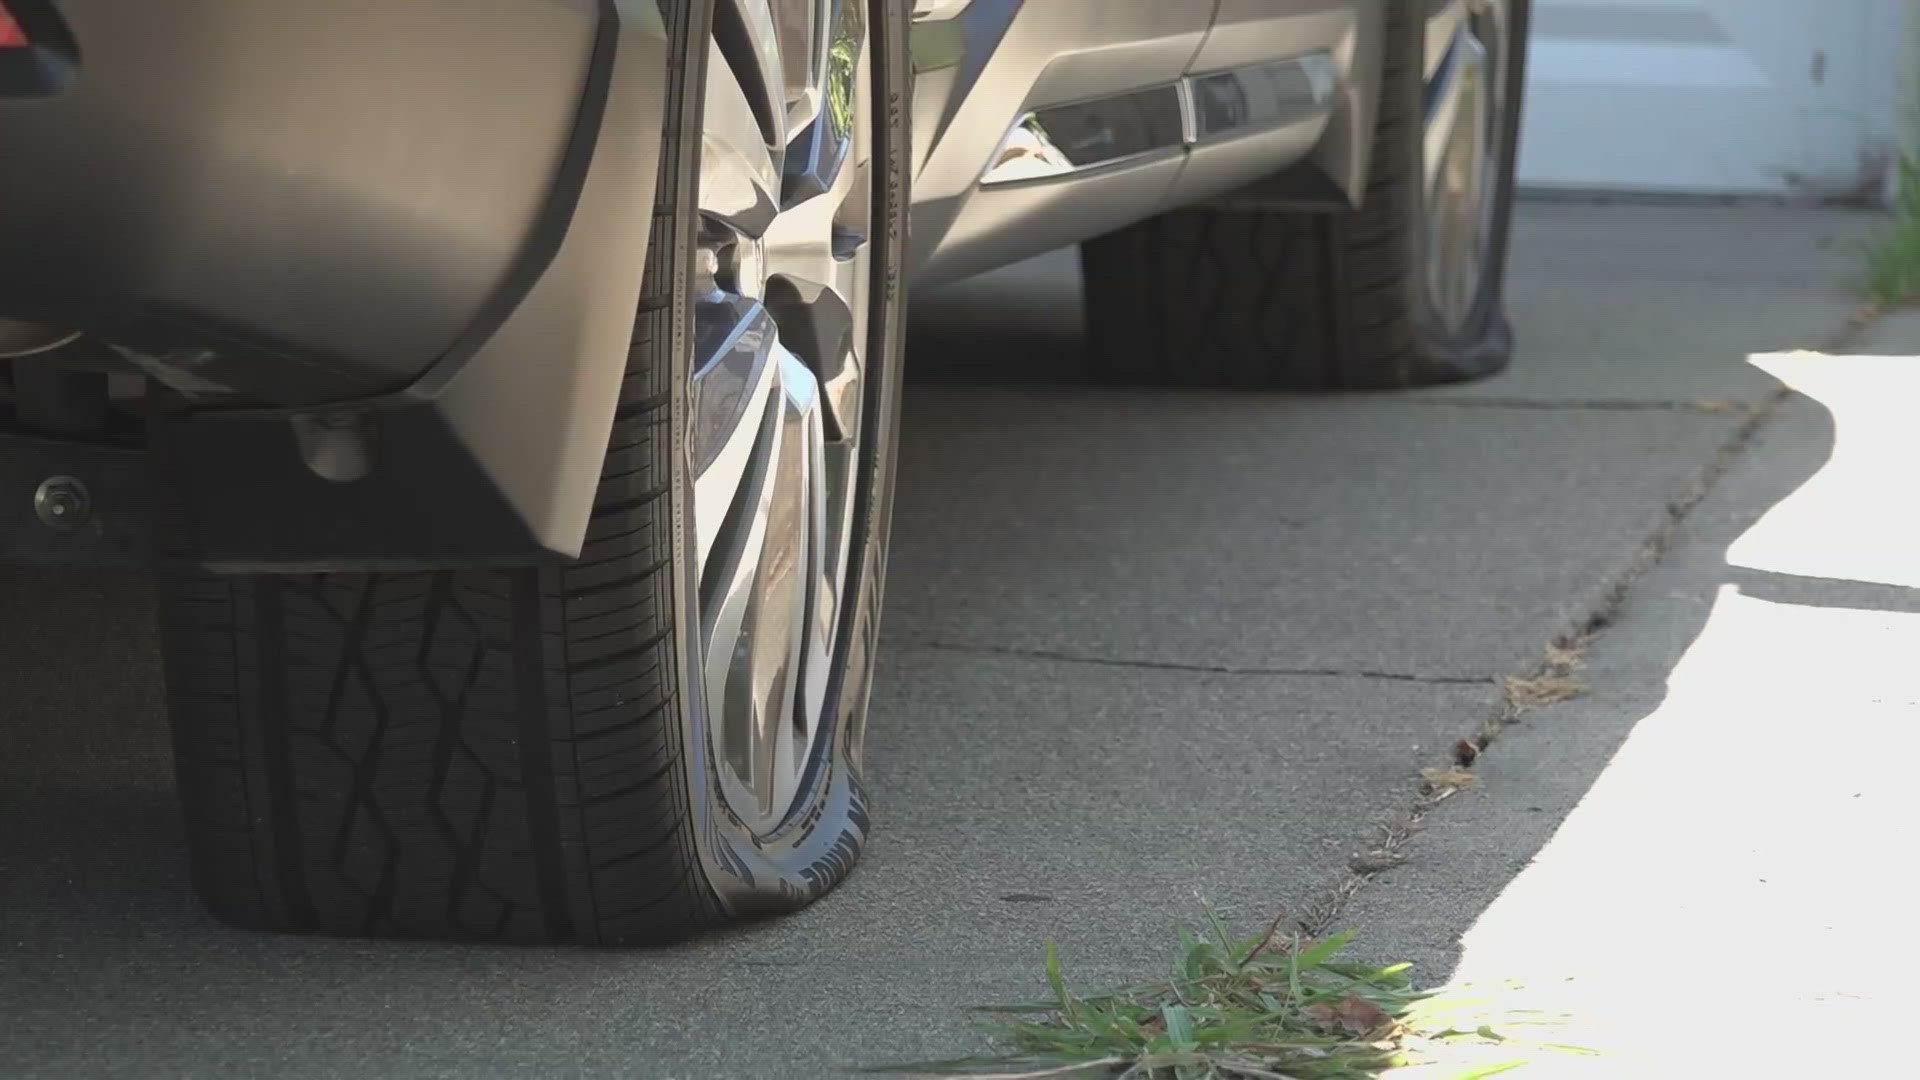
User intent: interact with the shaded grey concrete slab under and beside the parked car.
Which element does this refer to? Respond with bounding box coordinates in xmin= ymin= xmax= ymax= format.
xmin=0 ymin=206 xmax=1870 ymax=1080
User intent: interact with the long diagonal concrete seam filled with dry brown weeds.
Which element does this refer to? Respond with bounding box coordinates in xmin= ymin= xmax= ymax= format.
xmin=1294 ymin=306 xmax=1885 ymax=938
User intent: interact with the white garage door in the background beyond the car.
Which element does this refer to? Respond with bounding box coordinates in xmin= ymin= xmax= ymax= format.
xmin=1521 ymin=0 xmax=1901 ymax=196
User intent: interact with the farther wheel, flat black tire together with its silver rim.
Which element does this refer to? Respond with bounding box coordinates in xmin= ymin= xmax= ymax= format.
xmin=1081 ymin=0 xmax=1530 ymax=390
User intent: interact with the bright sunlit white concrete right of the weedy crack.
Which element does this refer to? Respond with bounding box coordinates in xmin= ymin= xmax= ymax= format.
xmin=1390 ymin=354 xmax=1920 ymax=1076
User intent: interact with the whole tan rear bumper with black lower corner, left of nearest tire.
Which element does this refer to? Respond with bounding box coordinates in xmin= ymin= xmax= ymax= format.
xmin=0 ymin=0 xmax=666 ymax=567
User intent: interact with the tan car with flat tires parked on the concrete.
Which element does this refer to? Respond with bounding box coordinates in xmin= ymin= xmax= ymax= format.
xmin=0 ymin=0 xmax=1528 ymax=945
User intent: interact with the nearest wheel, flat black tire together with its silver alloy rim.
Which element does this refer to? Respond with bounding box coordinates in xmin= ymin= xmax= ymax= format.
xmin=161 ymin=0 xmax=908 ymax=945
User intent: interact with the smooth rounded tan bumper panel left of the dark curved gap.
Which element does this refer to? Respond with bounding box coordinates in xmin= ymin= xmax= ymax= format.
xmin=0 ymin=0 xmax=601 ymax=404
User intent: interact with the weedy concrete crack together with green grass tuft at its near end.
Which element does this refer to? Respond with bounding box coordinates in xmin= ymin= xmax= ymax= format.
xmin=868 ymin=299 xmax=1889 ymax=1080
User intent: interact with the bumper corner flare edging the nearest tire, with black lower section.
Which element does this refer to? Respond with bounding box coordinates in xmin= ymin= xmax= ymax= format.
xmin=156 ymin=0 xmax=668 ymax=569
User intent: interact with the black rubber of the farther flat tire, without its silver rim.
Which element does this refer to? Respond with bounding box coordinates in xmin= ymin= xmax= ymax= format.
xmin=1081 ymin=0 xmax=1528 ymax=390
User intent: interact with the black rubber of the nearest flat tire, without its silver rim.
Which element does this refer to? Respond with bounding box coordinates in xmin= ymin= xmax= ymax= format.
xmin=161 ymin=0 xmax=906 ymax=945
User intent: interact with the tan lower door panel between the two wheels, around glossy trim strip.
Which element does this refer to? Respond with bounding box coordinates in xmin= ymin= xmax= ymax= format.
xmin=912 ymin=0 xmax=1384 ymax=284
